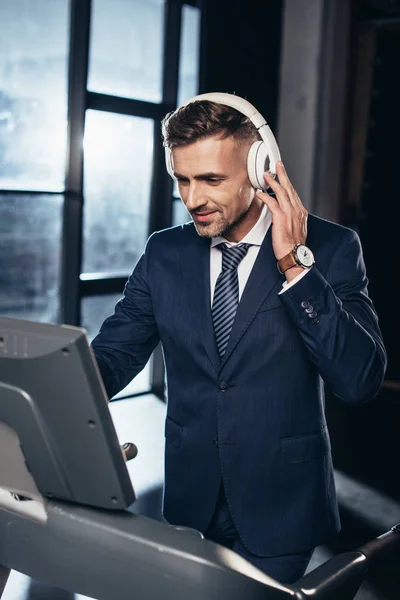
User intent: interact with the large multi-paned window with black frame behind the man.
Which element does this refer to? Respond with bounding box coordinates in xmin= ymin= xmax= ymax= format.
xmin=0 ymin=0 xmax=200 ymax=404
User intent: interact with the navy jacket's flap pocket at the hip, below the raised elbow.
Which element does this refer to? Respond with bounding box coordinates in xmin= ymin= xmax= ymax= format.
xmin=281 ymin=427 xmax=330 ymax=464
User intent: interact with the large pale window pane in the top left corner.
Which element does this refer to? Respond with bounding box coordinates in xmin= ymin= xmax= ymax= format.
xmin=0 ymin=0 xmax=69 ymax=191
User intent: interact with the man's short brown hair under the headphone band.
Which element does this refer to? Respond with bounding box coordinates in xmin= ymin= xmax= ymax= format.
xmin=161 ymin=100 xmax=261 ymax=149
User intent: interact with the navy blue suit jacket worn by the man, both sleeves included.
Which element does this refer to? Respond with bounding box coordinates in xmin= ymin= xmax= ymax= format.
xmin=92 ymin=215 xmax=386 ymax=556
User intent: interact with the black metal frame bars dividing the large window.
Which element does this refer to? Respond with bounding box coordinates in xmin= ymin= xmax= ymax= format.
xmin=0 ymin=0 xmax=202 ymax=399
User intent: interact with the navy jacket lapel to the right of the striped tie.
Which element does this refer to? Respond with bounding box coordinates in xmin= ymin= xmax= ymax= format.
xmin=221 ymin=227 xmax=284 ymax=369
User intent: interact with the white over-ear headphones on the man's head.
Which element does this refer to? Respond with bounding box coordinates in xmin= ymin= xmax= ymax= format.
xmin=165 ymin=92 xmax=281 ymax=190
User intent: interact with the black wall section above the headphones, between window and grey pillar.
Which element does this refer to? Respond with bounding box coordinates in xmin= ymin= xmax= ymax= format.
xmin=200 ymin=0 xmax=283 ymax=130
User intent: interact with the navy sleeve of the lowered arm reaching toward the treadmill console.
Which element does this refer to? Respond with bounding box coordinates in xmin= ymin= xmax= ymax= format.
xmin=91 ymin=238 xmax=159 ymax=398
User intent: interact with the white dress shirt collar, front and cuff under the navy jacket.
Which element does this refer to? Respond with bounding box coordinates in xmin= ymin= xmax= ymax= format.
xmin=210 ymin=204 xmax=310 ymax=305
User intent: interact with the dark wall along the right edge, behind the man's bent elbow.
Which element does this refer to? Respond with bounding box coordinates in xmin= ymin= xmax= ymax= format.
xmin=327 ymin=5 xmax=400 ymax=506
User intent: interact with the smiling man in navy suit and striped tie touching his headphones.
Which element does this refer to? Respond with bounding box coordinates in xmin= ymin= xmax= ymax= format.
xmin=93 ymin=100 xmax=386 ymax=582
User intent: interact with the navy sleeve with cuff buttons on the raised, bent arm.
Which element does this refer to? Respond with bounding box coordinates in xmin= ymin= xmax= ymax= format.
xmin=279 ymin=230 xmax=387 ymax=404
